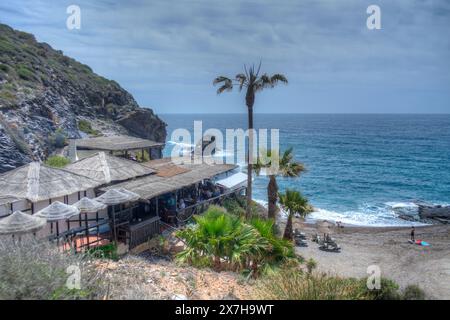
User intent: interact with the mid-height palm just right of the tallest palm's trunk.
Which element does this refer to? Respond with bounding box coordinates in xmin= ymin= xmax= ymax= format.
xmin=254 ymin=147 xmax=306 ymax=220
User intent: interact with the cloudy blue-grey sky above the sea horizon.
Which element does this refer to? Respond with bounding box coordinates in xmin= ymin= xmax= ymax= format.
xmin=0 ymin=0 xmax=450 ymax=113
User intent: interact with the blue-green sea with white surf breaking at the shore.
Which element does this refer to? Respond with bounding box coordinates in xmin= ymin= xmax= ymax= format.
xmin=161 ymin=114 xmax=450 ymax=226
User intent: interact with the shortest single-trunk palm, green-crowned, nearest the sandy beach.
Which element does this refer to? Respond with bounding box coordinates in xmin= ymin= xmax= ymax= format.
xmin=279 ymin=189 xmax=309 ymax=240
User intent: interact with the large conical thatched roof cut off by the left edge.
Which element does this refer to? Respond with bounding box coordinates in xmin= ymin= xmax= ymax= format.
xmin=0 ymin=162 xmax=101 ymax=202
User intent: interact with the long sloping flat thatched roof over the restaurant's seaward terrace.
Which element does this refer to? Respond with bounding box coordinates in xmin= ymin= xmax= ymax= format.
xmin=103 ymin=159 xmax=237 ymax=199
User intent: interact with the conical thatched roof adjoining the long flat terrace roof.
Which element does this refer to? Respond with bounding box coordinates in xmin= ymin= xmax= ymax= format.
xmin=65 ymin=152 xmax=155 ymax=184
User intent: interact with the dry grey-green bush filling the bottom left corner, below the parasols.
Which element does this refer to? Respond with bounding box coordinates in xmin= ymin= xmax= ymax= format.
xmin=0 ymin=236 xmax=102 ymax=300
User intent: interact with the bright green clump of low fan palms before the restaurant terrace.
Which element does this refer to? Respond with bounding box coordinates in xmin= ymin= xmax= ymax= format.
xmin=177 ymin=206 xmax=296 ymax=276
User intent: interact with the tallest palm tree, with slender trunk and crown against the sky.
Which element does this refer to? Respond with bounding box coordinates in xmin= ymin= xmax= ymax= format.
xmin=213 ymin=63 xmax=288 ymax=219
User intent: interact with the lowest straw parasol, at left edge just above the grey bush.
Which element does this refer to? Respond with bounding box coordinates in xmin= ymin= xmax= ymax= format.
xmin=0 ymin=211 xmax=46 ymax=235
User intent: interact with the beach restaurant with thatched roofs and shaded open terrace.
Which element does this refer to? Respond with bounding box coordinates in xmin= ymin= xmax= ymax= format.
xmin=0 ymin=138 xmax=245 ymax=249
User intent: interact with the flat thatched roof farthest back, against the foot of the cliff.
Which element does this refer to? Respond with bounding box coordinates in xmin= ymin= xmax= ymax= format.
xmin=75 ymin=135 xmax=164 ymax=151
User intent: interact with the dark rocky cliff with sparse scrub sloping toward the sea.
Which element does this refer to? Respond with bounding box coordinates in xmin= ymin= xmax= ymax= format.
xmin=0 ymin=24 xmax=166 ymax=172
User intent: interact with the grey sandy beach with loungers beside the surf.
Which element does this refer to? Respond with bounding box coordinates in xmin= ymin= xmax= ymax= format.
xmin=294 ymin=219 xmax=450 ymax=299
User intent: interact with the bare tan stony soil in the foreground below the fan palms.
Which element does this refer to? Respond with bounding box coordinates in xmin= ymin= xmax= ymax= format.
xmin=98 ymin=256 xmax=252 ymax=300
